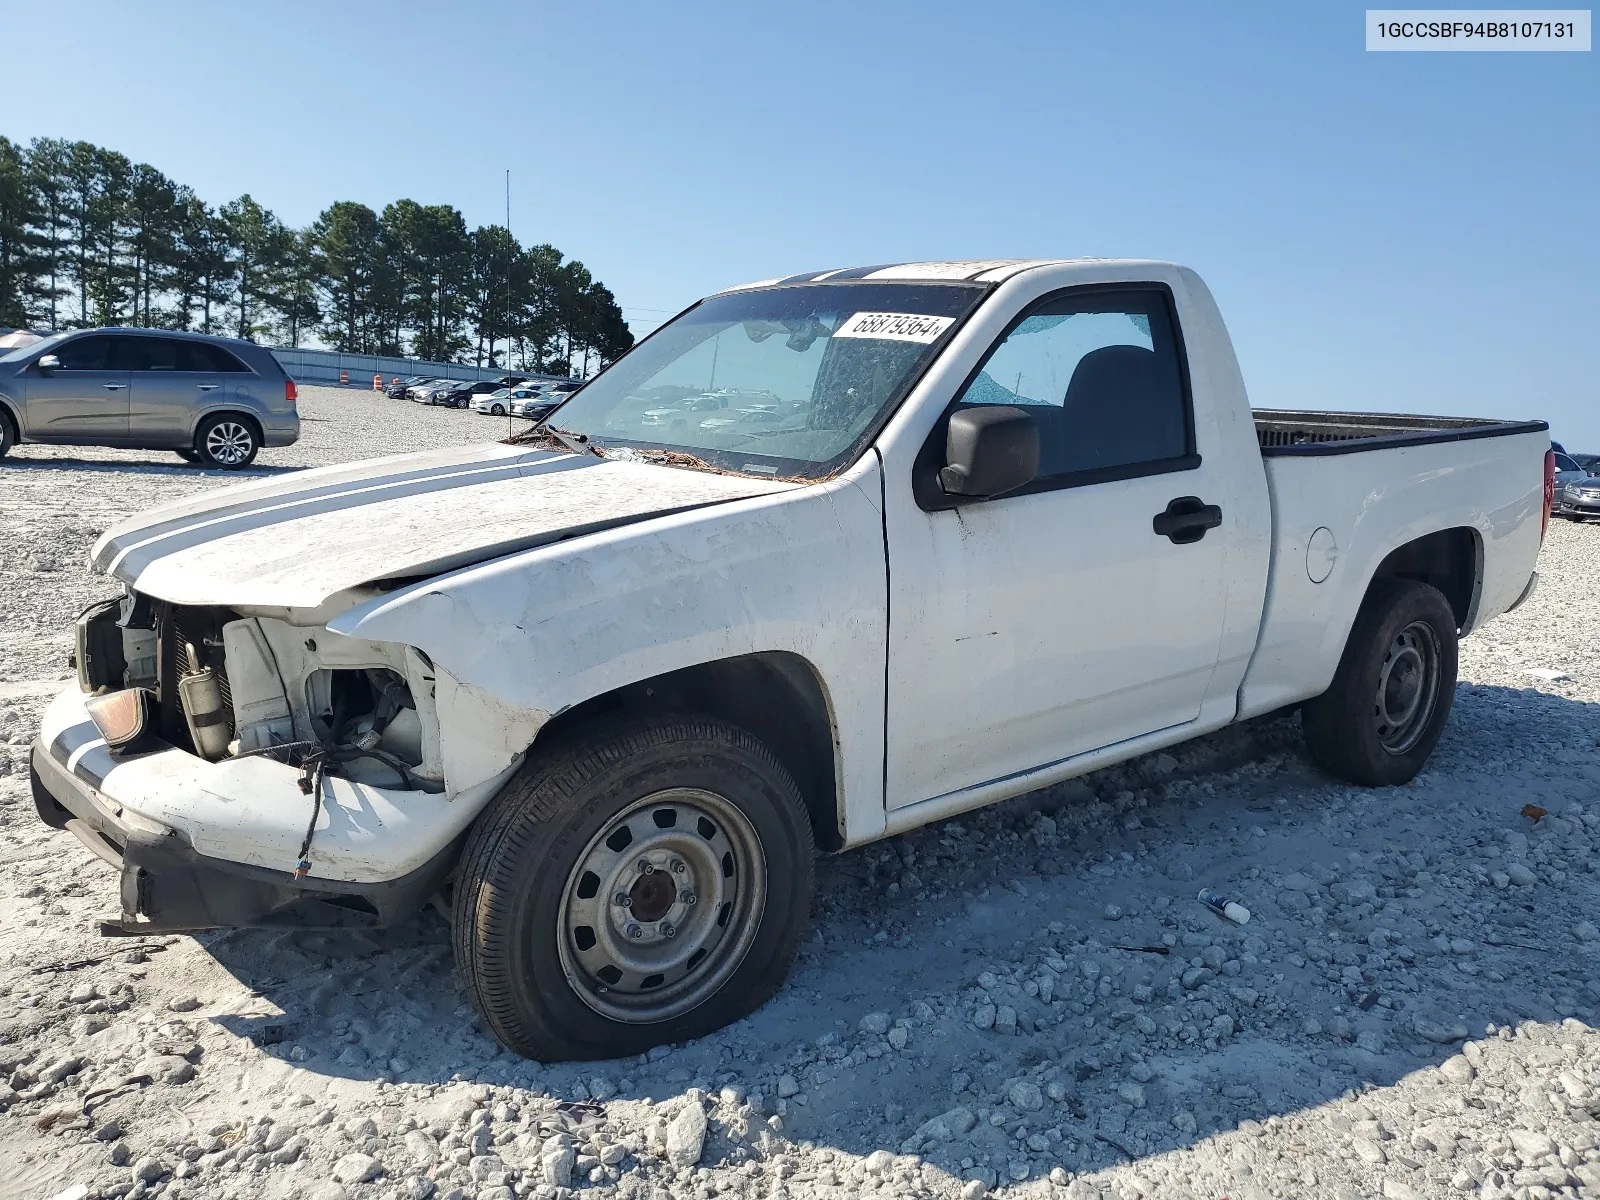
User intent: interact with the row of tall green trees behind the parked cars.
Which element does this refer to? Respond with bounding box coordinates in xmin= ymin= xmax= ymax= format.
xmin=0 ymin=138 xmax=634 ymax=374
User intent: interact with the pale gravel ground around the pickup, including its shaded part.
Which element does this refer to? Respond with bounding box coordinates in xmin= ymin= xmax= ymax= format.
xmin=0 ymin=387 xmax=1600 ymax=1200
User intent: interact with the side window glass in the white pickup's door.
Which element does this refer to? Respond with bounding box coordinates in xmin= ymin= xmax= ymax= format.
xmin=958 ymin=291 xmax=1194 ymax=477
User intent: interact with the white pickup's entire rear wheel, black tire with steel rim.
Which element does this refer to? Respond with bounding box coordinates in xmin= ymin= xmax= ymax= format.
xmin=1301 ymin=579 xmax=1458 ymax=787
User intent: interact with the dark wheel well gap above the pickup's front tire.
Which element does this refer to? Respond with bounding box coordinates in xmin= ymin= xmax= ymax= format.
xmin=539 ymin=651 xmax=843 ymax=850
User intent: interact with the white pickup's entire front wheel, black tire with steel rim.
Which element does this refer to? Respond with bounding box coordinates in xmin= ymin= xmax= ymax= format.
xmin=451 ymin=715 xmax=814 ymax=1062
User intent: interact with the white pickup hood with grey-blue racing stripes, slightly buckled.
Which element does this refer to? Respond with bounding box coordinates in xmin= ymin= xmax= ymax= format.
xmin=90 ymin=445 xmax=802 ymax=608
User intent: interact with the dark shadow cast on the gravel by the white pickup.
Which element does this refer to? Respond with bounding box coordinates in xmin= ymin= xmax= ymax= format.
xmin=206 ymin=685 xmax=1600 ymax=1184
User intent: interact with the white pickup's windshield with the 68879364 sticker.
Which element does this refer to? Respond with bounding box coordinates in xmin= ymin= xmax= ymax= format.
xmin=550 ymin=282 xmax=986 ymax=478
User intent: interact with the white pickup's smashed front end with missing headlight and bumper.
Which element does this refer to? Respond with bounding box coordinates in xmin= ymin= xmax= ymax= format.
xmin=34 ymin=589 xmax=531 ymax=933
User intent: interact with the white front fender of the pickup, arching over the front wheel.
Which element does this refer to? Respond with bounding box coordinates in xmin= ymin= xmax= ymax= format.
xmin=328 ymin=454 xmax=886 ymax=840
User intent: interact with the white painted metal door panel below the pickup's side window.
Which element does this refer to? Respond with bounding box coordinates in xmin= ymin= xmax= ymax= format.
xmin=888 ymin=467 xmax=1227 ymax=806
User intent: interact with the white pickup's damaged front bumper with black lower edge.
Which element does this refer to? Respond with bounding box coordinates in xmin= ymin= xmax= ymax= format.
xmin=32 ymin=686 xmax=480 ymax=933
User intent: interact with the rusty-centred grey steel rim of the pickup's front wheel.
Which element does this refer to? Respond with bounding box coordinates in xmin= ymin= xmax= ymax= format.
xmin=557 ymin=787 xmax=766 ymax=1024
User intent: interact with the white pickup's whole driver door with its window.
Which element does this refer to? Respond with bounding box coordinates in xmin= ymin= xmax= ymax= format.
xmin=886 ymin=286 xmax=1235 ymax=808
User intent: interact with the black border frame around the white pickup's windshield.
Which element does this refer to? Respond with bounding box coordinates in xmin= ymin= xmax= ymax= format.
xmin=531 ymin=278 xmax=1000 ymax=483
